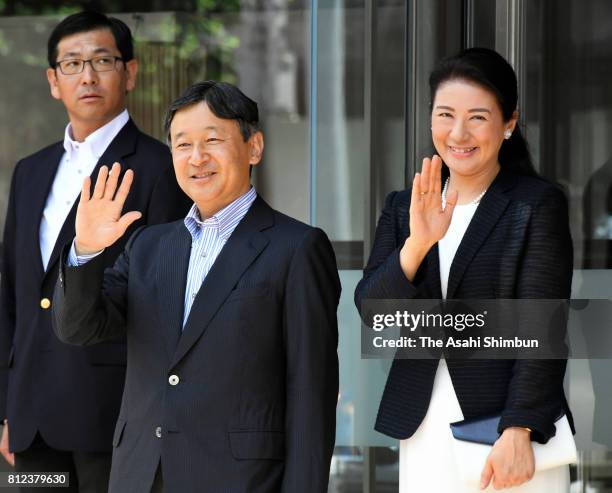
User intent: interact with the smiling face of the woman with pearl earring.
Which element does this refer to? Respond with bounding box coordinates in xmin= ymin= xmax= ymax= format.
xmin=431 ymin=79 xmax=518 ymax=180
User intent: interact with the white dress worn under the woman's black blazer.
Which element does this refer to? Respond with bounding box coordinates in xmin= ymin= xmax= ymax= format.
xmin=399 ymin=204 xmax=570 ymax=493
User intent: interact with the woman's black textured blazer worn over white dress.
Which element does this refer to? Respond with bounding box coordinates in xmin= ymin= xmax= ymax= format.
xmin=355 ymin=171 xmax=573 ymax=442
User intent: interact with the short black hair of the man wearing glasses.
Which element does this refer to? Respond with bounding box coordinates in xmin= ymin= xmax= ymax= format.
xmin=47 ymin=10 xmax=134 ymax=68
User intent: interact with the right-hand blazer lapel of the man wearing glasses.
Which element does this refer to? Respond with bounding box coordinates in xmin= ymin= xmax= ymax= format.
xmin=45 ymin=119 xmax=139 ymax=277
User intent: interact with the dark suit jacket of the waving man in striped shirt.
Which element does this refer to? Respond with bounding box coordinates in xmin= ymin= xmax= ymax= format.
xmin=54 ymin=197 xmax=340 ymax=493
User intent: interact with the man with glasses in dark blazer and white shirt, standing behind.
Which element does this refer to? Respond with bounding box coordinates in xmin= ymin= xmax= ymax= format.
xmin=0 ymin=12 xmax=189 ymax=492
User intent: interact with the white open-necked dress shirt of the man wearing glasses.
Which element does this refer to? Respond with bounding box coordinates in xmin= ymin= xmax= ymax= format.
xmin=38 ymin=110 xmax=130 ymax=270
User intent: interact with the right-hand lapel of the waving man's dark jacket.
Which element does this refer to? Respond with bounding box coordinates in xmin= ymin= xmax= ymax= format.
xmin=171 ymin=197 xmax=274 ymax=366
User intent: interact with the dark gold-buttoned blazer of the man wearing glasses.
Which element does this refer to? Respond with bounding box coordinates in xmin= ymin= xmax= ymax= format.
xmin=0 ymin=120 xmax=189 ymax=452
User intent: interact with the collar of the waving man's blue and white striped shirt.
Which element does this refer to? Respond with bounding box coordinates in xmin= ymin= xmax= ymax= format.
xmin=184 ymin=187 xmax=257 ymax=240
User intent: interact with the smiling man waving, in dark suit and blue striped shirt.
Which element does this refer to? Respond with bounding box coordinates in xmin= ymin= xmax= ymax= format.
xmin=53 ymin=81 xmax=340 ymax=493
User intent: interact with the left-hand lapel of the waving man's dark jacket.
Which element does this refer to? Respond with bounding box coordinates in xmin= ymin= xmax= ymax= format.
xmin=157 ymin=221 xmax=191 ymax=357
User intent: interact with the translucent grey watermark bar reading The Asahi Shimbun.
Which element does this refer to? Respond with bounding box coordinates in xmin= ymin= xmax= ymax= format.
xmin=361 ymin=299 xmax=612 ymax=359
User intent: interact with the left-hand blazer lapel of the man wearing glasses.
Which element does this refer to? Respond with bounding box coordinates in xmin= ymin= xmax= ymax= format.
xmin=29 ymin=142 xmax=64 ymax=279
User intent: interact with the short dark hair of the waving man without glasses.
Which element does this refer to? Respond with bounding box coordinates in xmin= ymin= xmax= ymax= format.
xmin=164 ymin=80 xmax=260 ymax=144
